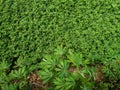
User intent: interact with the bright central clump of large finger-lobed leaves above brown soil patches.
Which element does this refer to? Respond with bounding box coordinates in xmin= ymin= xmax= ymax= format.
xmin=38 ymin=47 xmax=94 ymax=90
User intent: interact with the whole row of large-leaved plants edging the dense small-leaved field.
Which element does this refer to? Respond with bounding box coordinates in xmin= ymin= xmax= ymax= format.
xmin=0 ymin=46 xmax=120 ymax=90
